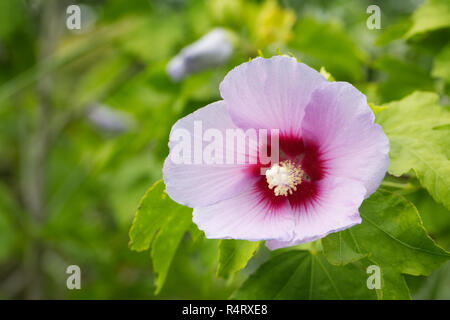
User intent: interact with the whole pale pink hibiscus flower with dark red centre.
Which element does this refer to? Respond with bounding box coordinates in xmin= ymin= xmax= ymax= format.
xmin=163 ymin=56 xmax=389 ymax=249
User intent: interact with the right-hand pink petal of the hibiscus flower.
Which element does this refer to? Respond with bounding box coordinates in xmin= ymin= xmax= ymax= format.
xmin=302 ymin=82 xmax=389 ymax=197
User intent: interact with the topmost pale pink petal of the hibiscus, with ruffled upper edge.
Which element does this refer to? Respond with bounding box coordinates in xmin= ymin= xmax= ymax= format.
xmin=220 ymin=56 xmax=326 ymax=135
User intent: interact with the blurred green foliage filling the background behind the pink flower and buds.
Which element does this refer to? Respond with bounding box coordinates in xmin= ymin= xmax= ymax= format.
xmin=0 ymin=0 xmax=450 ymax=299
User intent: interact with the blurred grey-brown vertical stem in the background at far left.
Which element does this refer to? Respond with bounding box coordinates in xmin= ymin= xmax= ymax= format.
xmin=22 ymin=0 xmax=61 ymax=299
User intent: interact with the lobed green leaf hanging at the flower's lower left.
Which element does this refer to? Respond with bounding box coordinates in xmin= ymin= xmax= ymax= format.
xmin=130 ymin=180 xmax=192 ymax=294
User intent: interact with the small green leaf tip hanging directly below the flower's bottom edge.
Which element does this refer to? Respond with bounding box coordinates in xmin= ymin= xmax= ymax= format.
xmin=217 ymin=240 xmax=260 ymax=278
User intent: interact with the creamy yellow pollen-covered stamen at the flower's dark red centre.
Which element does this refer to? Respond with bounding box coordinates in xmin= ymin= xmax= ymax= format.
xmin=266 ymin=160 xmax=303 ymax=196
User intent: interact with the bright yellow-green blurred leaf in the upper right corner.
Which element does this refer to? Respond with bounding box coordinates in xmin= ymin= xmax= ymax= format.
xmin=405 ymin=0 xmax=450 ymax=38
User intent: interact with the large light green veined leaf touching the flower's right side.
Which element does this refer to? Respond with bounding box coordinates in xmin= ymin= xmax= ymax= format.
xmin=376 ymin=91 xmax=450 ymax=208
